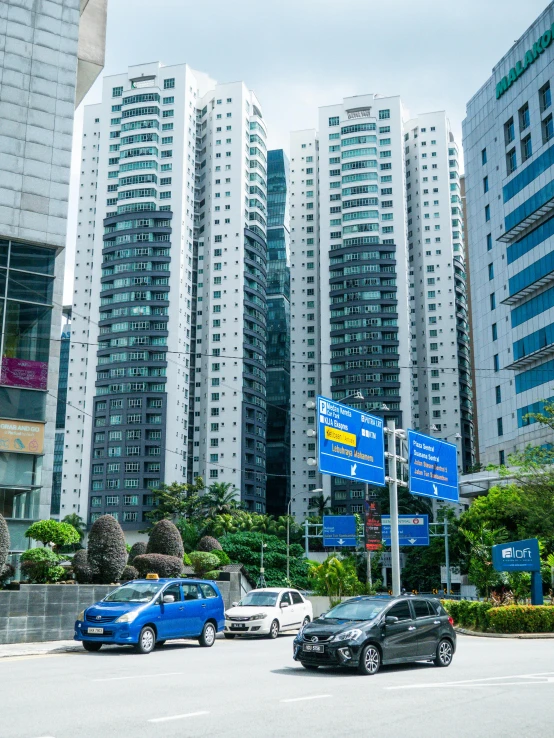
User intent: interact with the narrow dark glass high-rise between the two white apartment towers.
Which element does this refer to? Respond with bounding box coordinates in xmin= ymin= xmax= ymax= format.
xmin=266 ymin=149 xmax=290 ymax=508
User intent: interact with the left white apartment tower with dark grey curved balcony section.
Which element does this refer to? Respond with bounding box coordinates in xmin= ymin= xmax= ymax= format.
xmin=61 ymin=63 xmax=266 ymax=530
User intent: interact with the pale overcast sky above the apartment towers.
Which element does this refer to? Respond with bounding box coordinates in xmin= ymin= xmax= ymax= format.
xmin=64 ymin=0 xmax=547 ymax=302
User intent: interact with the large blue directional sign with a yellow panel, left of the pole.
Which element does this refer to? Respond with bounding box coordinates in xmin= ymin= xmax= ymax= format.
xmin=317 ymin=397 xmax=385 ymax=487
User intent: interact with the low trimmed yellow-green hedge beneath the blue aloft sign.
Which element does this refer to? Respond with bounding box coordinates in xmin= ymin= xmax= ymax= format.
xmin=442 ymin=600 xmax=554 ymax=633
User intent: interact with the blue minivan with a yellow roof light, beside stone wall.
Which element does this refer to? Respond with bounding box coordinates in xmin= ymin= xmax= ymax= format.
xmin=74 ymin=574 xmax=225 ymax=653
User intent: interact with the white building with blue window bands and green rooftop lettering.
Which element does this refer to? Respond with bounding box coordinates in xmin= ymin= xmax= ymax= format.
xmin=463 ymin=3 xmax=554 ymax=465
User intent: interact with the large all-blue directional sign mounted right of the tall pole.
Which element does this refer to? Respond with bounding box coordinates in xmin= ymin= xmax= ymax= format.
xmin=408 ymin=430 xmax=459 ymax=502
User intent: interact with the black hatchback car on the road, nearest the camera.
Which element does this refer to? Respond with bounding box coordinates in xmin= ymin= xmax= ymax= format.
xmin=294 ymin=595 xmax=456 ymax=674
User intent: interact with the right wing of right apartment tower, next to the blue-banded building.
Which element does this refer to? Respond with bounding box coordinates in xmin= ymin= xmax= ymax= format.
xmin=404 ymin=111 xmax=474 ymax=470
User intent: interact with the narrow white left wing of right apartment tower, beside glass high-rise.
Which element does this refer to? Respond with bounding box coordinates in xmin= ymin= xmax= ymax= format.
xmin=284 ymin=129 xmax=324 ymax=520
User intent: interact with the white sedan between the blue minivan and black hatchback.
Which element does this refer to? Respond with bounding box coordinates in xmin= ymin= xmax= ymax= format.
xmin=223 ymin=588 xmax=313 ymax=638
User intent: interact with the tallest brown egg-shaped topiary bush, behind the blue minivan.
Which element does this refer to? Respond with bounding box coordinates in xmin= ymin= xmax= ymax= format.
xmin=87 ymin=515 xmax=127 ymax=584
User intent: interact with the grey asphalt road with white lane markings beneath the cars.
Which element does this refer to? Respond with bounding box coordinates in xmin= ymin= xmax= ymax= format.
xmin=0 ymin=635 xmax=554 ymax=738
